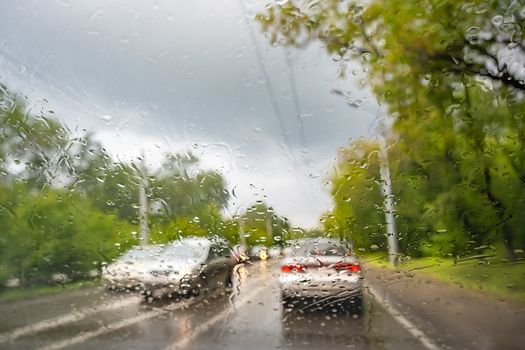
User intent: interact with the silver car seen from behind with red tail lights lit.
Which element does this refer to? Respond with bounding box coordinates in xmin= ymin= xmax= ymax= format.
xmin=279 ymin=238 xmax=363 ymax=313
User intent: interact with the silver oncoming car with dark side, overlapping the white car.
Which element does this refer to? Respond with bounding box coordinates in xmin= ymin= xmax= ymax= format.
xmin=141 ymin=237 xmax=236 ymax=298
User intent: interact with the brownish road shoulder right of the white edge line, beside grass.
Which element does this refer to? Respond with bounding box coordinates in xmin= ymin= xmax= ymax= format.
xmin=365 ymin=264 xmax=525 ymax=349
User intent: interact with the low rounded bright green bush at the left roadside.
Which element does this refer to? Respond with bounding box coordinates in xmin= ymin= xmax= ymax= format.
xmin=1 ymin=186 xmax=137 ymax=284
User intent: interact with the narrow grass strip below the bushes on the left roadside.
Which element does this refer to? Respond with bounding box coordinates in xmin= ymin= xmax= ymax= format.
xmin=0 ymin=279 xmax=100 ymax=302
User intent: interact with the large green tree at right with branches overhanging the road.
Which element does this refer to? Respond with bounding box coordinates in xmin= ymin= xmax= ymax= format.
xmin=258 ymin=0 xmax=525 ymax=260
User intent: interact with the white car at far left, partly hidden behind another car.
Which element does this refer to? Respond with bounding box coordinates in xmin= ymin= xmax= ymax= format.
xmin=101 ymin=245 xmax=164 ymax=290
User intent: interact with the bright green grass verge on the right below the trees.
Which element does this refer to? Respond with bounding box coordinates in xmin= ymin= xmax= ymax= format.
xmin=363 ymin=254 xmax=525 ymax=302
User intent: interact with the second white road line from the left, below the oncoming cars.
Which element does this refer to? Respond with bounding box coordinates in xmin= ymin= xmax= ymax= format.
xmin=41 ymin=300 xmax=197 ymax=350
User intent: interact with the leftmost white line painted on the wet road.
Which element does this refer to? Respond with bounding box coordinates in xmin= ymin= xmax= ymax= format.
xmin=0 ymin=298 xmax=140 ymax=344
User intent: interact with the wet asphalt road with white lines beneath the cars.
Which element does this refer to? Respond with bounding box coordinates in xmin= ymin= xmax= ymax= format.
xmin=0 ymin=261 xmax=520 ymax=350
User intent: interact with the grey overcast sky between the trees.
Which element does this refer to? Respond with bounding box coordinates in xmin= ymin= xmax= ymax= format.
xmin=0 ymin=0 xmax=374 ymax=227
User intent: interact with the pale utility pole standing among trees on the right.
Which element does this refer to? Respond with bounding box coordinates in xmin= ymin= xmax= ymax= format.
xmin=378 ymin=131 xmax=399 ymax=265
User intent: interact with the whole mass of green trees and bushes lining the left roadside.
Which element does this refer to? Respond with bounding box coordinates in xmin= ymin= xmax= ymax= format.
xmin=0 ymin=86 xmax=270 ymax=286
